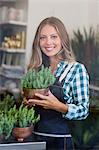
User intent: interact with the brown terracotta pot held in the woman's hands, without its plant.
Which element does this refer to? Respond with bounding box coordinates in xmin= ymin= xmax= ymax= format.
xmin=23 ymin=88 xmax=49 ymax=99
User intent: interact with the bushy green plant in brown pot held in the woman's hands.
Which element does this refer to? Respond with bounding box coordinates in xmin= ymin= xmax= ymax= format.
xmin=21 ymin=65 xmax=55 ymax=99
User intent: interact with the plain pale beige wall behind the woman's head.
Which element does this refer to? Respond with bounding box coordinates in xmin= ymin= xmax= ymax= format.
xmin=26 ymin=0 xmax=99 ymax=65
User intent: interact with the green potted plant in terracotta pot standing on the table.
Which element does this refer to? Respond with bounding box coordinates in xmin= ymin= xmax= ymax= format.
xmin=11 ymin=105 xmax=40 ymax=141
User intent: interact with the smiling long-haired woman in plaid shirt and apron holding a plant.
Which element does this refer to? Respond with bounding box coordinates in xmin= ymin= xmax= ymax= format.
xmin=28 ymin=17 xmax=89 ymax=150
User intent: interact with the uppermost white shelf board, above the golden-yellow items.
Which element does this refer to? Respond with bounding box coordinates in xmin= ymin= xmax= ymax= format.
xmin=0 ymin=20 xmax=27 ymax=26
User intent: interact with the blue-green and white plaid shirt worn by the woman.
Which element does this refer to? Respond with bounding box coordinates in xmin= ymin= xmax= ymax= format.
xmin=55 ymin=61 xmax=89 ymax=120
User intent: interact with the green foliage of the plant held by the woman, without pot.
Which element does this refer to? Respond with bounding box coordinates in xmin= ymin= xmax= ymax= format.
xmin=21 ymin=65 xmax=55 ymax=89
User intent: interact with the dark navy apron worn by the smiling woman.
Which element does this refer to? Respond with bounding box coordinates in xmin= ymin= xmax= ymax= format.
xmin=35 ymin=80 xmax=69 ymax=135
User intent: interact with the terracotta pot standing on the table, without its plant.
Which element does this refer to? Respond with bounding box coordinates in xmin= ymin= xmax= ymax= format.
xmin=13 ymin=126 xmax=33 ymax=142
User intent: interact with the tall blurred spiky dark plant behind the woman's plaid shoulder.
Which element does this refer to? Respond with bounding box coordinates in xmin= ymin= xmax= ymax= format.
xmin=71 ymin=27 xmax=99 ymax=85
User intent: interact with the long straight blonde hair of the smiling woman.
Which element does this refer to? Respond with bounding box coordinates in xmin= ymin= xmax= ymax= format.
xmin=29 ymin=17 xmax=75 ymax=68
